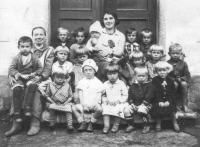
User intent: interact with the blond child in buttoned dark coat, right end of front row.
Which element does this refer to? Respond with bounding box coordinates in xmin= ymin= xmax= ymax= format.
xmin=147 ymin=61 xmax=180 ymax=132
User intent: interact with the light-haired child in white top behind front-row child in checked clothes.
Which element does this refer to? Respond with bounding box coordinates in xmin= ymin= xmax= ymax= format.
xmin=52 ymin=46 xmax=75 ymax=91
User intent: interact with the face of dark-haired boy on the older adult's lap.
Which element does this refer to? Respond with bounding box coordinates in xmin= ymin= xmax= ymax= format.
xmin=18 ymin=42 xmax=32 ymax=56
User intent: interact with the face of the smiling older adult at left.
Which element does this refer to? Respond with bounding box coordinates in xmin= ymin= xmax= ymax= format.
xmin=33 ymin=28 xmax=46 ymax=44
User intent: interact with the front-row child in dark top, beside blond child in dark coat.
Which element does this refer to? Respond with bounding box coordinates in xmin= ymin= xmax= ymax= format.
xmin=124 ymin=67 xmax=151 ymax=133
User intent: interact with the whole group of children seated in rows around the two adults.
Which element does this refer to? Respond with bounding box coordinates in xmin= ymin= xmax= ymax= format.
xmin=6 ymin=22 xmax=190 ymax=134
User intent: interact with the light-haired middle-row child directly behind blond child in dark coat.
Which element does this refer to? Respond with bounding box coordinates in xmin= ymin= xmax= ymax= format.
xmin=146 ymin=44 xmax=164 ymax=79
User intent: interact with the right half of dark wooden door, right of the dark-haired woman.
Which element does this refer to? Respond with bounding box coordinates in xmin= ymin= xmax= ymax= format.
xmin=103 ymin=0 xmax=156 ymax=39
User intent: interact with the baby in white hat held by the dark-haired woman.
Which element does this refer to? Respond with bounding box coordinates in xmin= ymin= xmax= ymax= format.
xmin=86 ymin=21 xmax=102 ymax=51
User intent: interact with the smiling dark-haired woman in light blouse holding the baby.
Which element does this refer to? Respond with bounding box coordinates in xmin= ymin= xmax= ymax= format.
xmin=93 ymin=12 xmax=125 ymax=81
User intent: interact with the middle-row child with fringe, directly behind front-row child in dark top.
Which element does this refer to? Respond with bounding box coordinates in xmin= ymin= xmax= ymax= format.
xmin=119 ymin=51 xmax=145 ymax=86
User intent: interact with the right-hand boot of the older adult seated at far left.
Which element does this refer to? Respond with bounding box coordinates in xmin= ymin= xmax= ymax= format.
xmin=27 ymin=117 xmax=40 ymax=136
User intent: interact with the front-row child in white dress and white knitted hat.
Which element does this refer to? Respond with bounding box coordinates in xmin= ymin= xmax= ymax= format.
xmin=72 ymin=59 xmax=103 ymax=132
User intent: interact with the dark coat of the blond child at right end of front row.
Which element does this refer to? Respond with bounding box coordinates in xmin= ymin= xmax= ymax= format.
xmin=149 ymin=76 xmax=176 ymax=118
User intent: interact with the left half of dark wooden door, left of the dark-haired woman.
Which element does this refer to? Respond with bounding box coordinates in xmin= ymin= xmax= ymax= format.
xmin=51 ymin=0 xmax=101 ymax=45
